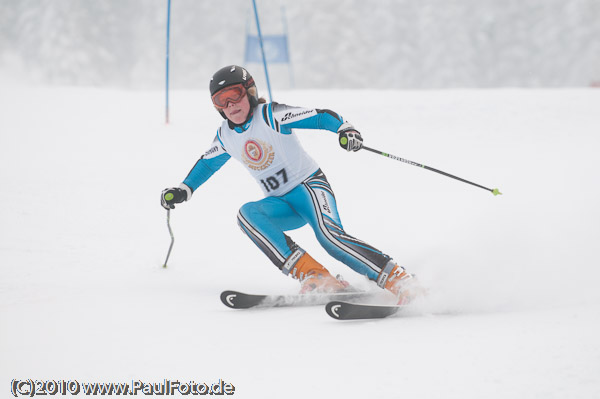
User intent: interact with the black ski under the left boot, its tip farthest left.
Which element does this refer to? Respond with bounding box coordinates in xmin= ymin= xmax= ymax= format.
xmin=221 ymin=291 xmax=375 ymax=309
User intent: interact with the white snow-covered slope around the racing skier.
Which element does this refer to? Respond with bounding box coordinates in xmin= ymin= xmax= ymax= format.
xmin=0 ymin=87 xmax=600 ymax=399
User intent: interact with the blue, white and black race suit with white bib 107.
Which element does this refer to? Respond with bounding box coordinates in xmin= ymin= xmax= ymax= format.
xmin=182 ymin=103 xmax=390 ymax=280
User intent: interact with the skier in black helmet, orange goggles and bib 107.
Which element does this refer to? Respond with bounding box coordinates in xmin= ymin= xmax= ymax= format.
xmin=161 ymin=65 xmax=415 ymax=304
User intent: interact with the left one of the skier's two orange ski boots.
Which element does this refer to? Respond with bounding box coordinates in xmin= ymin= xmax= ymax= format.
xmin=283 ymin=251 xmax=350 ymax=294
